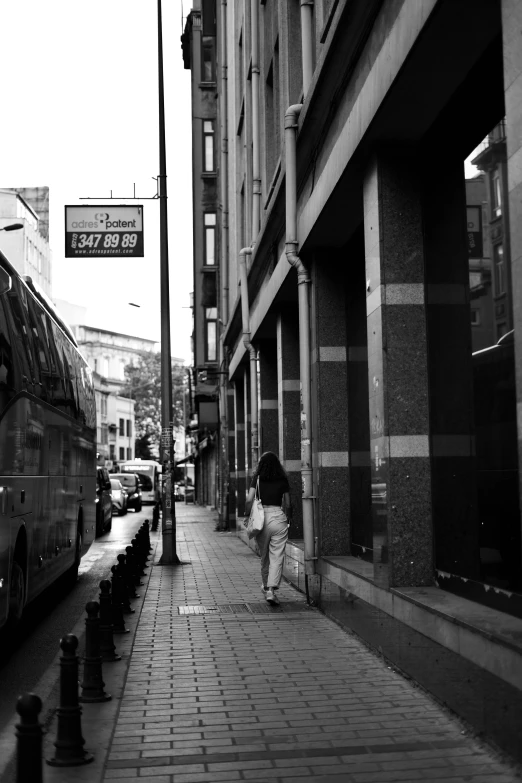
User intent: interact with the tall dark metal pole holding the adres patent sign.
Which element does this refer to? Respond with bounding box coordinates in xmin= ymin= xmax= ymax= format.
xmin=158 ymin=0 xmax=180 ymax=565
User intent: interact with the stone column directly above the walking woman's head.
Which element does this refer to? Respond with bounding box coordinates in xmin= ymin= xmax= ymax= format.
xmin=259 ymin=340 xmax=279 ymax=455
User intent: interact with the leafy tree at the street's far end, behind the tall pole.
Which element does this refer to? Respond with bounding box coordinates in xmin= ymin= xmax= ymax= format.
xmin=121 ymin=352 xmax=186 ymax=459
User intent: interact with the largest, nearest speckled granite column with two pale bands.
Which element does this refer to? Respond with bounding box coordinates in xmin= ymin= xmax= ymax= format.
xmin=363 ymin=149 xmax=434 ymax=587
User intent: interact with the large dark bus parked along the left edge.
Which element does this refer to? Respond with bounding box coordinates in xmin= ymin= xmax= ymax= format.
xmin=0 ymin=252 xmax=96 ymax=627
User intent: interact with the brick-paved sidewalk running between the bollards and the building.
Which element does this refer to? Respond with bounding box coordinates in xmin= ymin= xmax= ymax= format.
xmin=103 ymin=504 xmax=521 ymax=783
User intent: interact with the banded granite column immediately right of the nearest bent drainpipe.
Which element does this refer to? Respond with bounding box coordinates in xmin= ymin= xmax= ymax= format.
xmin=311 ymin=258 xmax=351 ymax=555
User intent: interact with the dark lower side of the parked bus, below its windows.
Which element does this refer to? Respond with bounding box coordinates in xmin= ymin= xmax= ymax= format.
xmin=0 ymin=395 xmax=96 ymax=626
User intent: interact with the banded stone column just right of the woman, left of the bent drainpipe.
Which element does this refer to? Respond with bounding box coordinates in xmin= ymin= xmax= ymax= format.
xmin=277 ymin=306 xmax=303 ymax=539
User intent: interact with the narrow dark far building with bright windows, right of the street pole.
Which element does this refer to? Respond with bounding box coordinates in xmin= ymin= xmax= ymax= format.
xmin=181 ymin=0 xmax=221 ymax=507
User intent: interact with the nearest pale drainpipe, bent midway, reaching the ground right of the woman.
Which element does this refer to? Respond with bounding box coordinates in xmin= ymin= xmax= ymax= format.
xmin=285 ymin=104 xmax=317 ymax=576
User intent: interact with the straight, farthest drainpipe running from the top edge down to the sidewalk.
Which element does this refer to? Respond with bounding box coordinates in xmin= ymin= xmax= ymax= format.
xmin=218 ymin=0 xmax=229 ymax=529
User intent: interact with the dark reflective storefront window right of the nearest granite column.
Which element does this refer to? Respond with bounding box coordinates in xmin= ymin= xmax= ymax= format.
xmin=457 ymin=115 xmax=522 ymax=597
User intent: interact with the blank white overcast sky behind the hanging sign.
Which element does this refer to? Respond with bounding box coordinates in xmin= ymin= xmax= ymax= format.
xmin=0 ymin=0 xmax=192 ymax=361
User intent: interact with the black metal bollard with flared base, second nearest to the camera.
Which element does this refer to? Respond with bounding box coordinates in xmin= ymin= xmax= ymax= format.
xmin=46 ymin=633 xmax=93 ymax=767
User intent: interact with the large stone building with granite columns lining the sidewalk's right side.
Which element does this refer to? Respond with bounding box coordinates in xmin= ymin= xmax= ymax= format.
xmin=182 ymin=0 xmax=522 ymax=754
